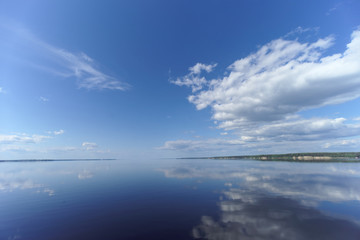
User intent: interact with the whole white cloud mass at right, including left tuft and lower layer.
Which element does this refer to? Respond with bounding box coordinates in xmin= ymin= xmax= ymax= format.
xmin=168 ymin=28 xmax=360 ymax=152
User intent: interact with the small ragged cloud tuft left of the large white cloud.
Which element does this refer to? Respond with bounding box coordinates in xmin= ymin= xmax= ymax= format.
xmin=170 ymin=63 xmax=217 ymax=92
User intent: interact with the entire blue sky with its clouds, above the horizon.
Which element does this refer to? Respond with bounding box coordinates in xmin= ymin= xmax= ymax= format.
xmin=0 ymin=0 xmax=360 ymax=159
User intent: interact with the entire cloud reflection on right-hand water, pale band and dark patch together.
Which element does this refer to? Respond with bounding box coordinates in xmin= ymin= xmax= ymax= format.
xmin=161 ymin=161 xmax=360 ymax=240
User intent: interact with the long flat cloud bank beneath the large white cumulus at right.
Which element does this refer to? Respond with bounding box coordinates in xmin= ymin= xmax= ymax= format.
xmin=158 ymin=118 xmax=360 ymax=152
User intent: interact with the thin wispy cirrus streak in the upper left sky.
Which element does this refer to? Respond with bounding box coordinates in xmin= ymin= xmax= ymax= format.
xmin=0 ymin=24 xmax=130 ymax=91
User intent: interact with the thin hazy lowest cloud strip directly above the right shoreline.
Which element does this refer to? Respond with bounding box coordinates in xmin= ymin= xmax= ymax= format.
xmin=158 ymin=133 xmax=360 ymax=157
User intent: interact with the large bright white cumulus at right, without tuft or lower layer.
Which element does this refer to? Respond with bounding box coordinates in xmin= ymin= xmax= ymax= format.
xmin=183 ymin=30 xmax=360 ymax=123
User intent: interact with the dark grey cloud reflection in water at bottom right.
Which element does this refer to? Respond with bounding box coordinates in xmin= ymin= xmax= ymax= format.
xmin=193 ymin=193 xmax=360 ymax=240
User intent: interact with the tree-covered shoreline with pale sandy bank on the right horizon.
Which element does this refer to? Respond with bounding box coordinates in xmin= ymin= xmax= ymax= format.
xmin=179 ymin=152 xmax=360 ymax=162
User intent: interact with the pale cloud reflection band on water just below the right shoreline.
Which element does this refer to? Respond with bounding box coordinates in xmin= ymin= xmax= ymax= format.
xmin=161 ymin=161 xmax=360 ymax=205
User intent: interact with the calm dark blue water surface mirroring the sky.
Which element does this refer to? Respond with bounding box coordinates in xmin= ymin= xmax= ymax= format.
xmin=0 ymin=159 xmax=360 ymax=240
